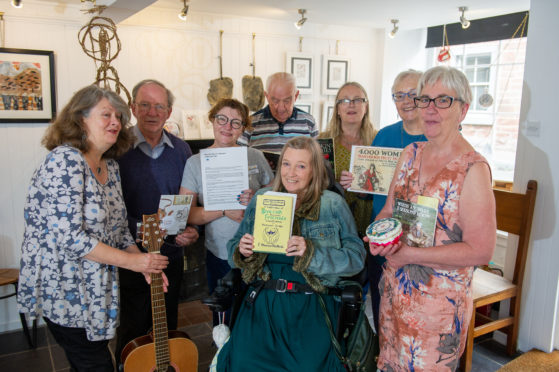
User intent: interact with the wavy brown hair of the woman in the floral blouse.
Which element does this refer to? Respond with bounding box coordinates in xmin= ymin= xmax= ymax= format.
xmin=41 ymin=85 xmax=134 ymax=159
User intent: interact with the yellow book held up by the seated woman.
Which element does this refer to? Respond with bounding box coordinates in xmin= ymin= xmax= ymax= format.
xmin=253 ymin=191 xmax=297 ymax=254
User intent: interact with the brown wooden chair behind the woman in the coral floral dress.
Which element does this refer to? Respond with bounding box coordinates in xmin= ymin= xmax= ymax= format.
xmin=461 ymin=180 xmax=538 ymax=372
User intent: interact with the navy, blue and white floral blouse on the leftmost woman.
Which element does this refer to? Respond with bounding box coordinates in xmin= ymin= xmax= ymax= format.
xmin=17 ymin=146 xmax=134 ymax=341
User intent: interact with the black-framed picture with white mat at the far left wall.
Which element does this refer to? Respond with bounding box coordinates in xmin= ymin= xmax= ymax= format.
xmin=0 ymin=48 xmax=56 ymax=123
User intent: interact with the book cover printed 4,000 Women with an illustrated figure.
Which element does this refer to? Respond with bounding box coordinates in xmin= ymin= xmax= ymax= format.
xmin=348 ymin=146 xmax=402 ymax=195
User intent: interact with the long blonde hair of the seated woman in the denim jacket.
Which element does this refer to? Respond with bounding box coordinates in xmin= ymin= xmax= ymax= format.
xmin=272 ymin=136 xmax=329 ymax=204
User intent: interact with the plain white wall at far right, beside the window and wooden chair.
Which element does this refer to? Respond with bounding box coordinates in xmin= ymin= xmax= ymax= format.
xmin=507 ymin=0 xmax=559 ymax=352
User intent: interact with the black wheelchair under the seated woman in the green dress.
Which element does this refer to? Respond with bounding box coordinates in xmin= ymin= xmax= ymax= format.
xmin=202 ymin=269 xmax=367 ymax=343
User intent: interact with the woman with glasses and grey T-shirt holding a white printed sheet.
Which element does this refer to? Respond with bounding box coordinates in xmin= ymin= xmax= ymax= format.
xmin=180 ymin=99 xmax=274 ymax=325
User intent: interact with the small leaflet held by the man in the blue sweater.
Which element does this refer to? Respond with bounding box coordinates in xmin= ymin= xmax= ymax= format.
xmin=158 ymin=195 xmax=192 ymax=235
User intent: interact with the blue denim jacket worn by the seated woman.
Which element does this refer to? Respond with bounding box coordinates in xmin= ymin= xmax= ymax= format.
xmin=227 ymin=188 xmax=366 ymax=290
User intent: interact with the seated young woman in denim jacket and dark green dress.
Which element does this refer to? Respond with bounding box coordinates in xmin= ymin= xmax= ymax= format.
xmin=212 ymin=136 xmax=365 ymax=371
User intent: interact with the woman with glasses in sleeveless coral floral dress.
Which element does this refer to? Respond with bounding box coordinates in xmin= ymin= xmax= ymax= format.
xmin=365 ymin=66 xmax=496 ymax=371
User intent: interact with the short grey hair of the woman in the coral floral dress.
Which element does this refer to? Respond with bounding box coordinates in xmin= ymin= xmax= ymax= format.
xmin=417 ymin=66 xmax=472 ymax=104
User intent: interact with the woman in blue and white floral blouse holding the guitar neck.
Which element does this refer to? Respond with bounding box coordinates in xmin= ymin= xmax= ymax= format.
xmin=17 ymin=85 xmax=168 ymax=371
